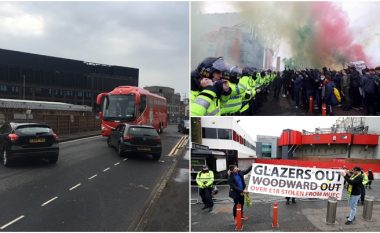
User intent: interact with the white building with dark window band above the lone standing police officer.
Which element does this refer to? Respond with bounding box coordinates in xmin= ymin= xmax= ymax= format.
xmin=201 ymin=117 xmax=256 ymax=159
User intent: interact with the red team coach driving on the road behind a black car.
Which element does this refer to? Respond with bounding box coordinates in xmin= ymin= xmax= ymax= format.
xmin=96 ymin=86 xmax=168 ymax=136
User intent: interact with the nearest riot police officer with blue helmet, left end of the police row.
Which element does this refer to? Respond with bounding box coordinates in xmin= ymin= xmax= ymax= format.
xmin=191 ymin=57 xmax=231 ymax=116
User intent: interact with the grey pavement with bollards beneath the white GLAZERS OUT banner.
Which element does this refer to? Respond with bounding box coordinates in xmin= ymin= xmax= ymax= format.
xmin=191 ymin=181 xmax=380 ymax=232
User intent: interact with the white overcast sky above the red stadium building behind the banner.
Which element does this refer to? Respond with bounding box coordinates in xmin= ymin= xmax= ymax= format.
xmin=235 ymin=116 xmax=339 ymax=141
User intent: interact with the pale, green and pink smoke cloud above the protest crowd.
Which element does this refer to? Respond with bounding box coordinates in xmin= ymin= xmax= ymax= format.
xmin=233 ymin=2 xmax=370 ymax=68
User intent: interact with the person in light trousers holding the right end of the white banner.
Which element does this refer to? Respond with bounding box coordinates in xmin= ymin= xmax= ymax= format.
xmin=342 ymin=167 xmax=363 ymax=225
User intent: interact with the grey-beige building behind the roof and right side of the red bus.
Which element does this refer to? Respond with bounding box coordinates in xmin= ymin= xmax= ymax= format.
xmin=144 ymin=86 xmax=181 ymax=123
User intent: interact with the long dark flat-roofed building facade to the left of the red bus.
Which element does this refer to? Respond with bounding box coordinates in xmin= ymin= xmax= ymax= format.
xmin=0 ymin=49 xmax=139 ymax=108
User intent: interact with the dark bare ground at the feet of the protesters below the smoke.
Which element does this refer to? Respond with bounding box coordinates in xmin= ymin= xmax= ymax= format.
xmin=254 ymin=92 xmax=365 ymax=116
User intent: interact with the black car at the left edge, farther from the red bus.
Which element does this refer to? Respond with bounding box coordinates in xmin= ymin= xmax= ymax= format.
xmin=0 ymin=122 xmax=59 ymax=166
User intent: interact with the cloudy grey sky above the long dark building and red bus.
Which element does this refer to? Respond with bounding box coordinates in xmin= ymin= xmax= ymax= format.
xmin=0 ymin=2 xmax=189 ymax=97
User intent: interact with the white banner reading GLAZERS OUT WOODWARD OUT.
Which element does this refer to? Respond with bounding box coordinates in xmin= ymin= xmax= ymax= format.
xmin=248 ymin=163 xmax=344 ymax=200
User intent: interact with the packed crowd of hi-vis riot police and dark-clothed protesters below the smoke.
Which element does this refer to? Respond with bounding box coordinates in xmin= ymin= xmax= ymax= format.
xmin=191 ymin=57 xmax=380 ymax=116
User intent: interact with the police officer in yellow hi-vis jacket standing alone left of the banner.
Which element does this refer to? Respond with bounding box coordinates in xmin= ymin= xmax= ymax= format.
xmin=196 ymin=165 xmax=214 ymax=212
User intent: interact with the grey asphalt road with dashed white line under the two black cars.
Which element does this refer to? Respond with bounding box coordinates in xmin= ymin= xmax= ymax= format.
xmin=0 ymin=125 xmax=187 ymax=231
